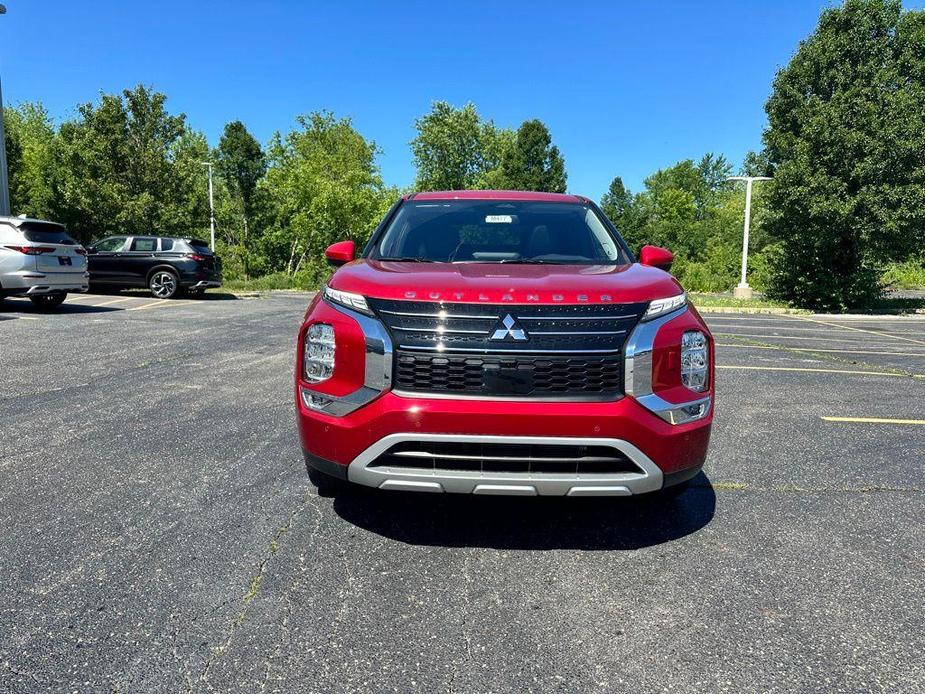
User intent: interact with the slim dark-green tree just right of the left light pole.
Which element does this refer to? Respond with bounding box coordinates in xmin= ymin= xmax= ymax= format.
xmin=216 ymin=121 xmax=267 ymax=279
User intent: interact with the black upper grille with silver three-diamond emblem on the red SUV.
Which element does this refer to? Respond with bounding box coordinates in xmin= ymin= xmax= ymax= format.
xmin=368 ymin=299 xmax=646 ymax=400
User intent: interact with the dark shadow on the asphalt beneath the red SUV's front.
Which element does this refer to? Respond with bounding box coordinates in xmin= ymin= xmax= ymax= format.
xmin=334 ymin=473 xmax=716 ymax=550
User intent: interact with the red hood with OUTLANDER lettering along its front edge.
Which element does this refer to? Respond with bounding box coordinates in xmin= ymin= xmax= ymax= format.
xmin=329 ymin=259 xmax=682 ymax=304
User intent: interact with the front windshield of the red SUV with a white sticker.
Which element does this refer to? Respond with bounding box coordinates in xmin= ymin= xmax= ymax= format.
xmin=369 ymin=200 xmax=631 ymax=265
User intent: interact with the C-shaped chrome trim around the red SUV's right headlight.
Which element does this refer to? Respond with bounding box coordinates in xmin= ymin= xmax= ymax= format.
xmin=623 ymin=304 xmax=712 ymax=425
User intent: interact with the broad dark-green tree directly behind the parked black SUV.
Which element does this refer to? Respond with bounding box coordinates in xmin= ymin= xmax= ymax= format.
xmin=52 ymin=85 xmax=209 ymax=241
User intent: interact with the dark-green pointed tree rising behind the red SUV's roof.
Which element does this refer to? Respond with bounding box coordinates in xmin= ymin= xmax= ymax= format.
xmin=501 ymin=119 xmax=566 ymax=193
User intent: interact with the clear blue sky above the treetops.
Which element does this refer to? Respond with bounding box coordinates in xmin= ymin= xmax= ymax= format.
xmin=0 ymin=0 xmax=908 ymax=198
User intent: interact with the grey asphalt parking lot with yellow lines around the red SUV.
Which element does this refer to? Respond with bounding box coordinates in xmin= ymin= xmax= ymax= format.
xmin=0 ymin=294 xmax=925 ymax=692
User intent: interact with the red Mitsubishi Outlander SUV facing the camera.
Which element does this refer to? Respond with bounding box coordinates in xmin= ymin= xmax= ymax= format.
xmin=295 ymin=191 xmax=714 ymax=496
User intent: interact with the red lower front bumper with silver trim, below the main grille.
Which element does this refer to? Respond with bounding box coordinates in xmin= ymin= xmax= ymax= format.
xmin=299 ymin=392 xmax=712 ymax=496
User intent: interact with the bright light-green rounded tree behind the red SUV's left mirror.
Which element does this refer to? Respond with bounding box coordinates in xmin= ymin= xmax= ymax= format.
xmin=261 ymin=112 xmax=397 ymax=276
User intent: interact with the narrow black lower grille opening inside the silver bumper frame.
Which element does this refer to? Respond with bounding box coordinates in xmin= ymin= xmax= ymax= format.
xmin=367 ymin=441 xmax=640 ymax=475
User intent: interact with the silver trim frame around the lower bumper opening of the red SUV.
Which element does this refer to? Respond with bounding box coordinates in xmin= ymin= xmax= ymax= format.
xmin=347 ymin=433 xmax=664 ymax=496
